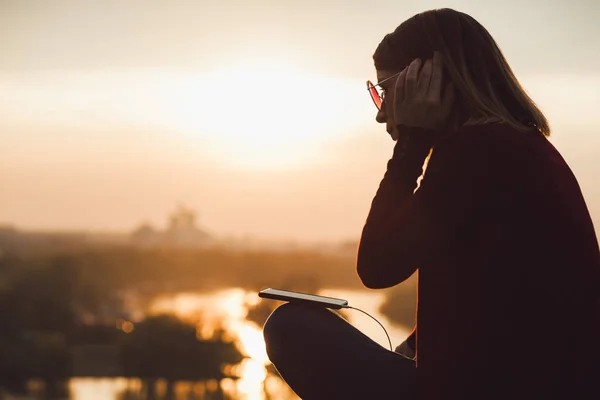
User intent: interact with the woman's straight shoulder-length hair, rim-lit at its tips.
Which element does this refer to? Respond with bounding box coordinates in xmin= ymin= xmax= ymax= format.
xmin=373 ymin=8 xmax=550 ymax=136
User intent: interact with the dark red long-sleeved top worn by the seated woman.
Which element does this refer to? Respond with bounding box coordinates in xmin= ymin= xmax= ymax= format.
xmin=357 ymin=124 xmax=600 ymax=400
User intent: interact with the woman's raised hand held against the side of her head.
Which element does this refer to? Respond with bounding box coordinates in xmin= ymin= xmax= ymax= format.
xmin=394 ymin=51 xmax=454 ymax=131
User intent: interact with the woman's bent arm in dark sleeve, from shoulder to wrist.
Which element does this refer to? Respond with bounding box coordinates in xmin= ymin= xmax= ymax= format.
xmin=357 ymin=126 xmax=494 ymax=288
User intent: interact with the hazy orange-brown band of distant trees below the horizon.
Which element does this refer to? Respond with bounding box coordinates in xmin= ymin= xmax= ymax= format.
xmin=0 ymin=246 xmax=361 ymax=291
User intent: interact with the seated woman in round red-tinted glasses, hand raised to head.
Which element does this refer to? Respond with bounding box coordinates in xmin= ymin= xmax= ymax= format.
xmin=264 ymin=9 xmax=600 ymax=400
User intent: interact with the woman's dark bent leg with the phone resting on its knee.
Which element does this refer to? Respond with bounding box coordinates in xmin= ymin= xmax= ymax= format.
xmin=264 ymin=303 xmax=416 ymax=400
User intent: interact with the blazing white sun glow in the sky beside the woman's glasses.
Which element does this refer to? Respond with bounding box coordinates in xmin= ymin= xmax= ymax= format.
xmin=165 ymin=61 xmax=371 ymax=168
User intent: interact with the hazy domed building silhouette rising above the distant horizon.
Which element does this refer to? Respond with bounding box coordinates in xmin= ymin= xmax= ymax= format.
xmin=131 ymin=205 xmax=215 ymax=248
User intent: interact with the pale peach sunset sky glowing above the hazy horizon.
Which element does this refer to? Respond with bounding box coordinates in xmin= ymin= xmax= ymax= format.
xmin=0 ymin=0 xmax=600 ymax=241
